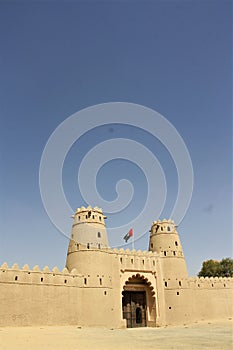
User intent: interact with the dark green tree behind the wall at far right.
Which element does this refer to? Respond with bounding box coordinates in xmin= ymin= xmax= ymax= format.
xmin=198 ymin=258 xmax=233 ymax=277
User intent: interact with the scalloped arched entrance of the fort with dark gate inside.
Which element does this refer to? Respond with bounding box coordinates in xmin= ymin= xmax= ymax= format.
xmin=122 ymin=274 xmax=156 ymax=328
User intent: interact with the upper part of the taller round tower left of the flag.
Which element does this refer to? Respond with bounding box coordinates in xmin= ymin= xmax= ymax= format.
xmin=66 ymin=206 xmax=109 ymax=270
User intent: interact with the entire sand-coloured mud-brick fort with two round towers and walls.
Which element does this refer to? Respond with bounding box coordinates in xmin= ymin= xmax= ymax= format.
xmin=0 ymin=206 xmax=233 ymax=328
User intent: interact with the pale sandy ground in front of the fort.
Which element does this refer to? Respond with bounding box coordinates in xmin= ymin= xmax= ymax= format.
xmin=0 ymin=320 xmax=233 ymax=350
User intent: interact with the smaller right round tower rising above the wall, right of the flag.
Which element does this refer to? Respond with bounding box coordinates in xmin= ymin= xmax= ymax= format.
xmin=149 ymin=219 xmax=188 ymax=279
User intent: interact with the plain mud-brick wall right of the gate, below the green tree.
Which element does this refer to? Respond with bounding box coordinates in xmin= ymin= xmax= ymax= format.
xmin=164 ymin=278 xmax=233 ymax=325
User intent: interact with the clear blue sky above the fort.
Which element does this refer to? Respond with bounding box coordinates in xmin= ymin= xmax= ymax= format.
xmin=0 ymin=0 xmax=232 ymax=275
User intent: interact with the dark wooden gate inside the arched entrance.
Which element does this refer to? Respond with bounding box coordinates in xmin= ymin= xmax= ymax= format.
xmin=122 ymin=291 xmax=146 ymax=328
